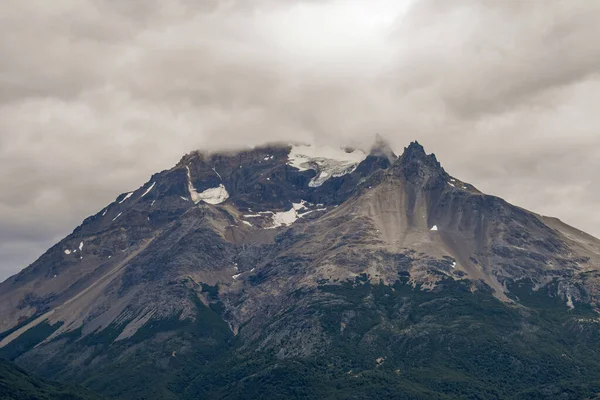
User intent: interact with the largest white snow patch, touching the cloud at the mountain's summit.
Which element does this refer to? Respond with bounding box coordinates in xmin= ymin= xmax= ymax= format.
xmin=288 ymin=145 xmax=367 ymax=187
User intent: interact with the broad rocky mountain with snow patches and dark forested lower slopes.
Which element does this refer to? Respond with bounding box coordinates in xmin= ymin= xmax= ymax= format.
xmin=0 ymin=138 xmax=600 ymax=399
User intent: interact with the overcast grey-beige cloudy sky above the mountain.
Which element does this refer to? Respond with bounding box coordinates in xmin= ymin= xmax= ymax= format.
xmin=0 ymin=0 xmax=600 ymax=280
